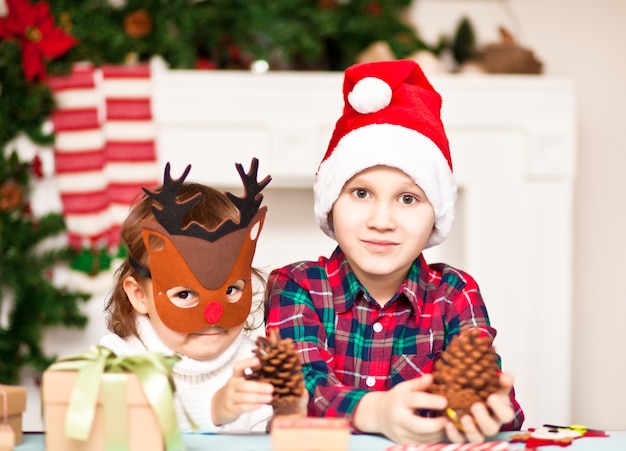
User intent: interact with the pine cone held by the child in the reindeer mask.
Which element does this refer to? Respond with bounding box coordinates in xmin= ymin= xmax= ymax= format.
xmin=246 ymin=329 xmax=304 ymax=415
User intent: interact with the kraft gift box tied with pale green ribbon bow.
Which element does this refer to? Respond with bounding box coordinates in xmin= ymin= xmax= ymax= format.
xmin=42 ymin=346 xmax=184 ymax=451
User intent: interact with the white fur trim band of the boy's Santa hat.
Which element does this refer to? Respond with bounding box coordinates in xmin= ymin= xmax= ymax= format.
xmin=313 ymin=124 xmax=456 ymax=248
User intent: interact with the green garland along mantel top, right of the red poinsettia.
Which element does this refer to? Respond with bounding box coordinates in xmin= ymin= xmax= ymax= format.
xmin=42 ymin=0 xmax=426 ymax=71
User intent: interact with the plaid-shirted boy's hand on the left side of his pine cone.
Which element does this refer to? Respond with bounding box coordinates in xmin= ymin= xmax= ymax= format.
xmin=353 ymin=374 xmax=448 ymax=444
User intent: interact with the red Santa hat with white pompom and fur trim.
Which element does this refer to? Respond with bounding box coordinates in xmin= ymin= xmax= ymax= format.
xmin=314 ymin=60 xmax=456 ymax=251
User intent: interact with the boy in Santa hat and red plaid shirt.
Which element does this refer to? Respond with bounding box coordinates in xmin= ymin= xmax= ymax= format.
xmin=267 ymin=57 xmax=523 ymax=443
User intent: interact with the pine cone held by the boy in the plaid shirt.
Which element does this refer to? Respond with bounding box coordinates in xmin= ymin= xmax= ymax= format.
xmin=431 ymin=328 xmax=500 ymax=429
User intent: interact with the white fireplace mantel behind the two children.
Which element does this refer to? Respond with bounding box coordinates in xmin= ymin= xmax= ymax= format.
xmin=20 ymin=70 xmax=576 ymax=429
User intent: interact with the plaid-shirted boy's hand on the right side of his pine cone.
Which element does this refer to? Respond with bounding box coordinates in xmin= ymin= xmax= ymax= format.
xmin=446 ymin=373 xmax=515 ymax=443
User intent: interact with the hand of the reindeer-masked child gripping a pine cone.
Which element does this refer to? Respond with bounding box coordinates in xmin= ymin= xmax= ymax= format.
xmin=211 ymin=357 xmax=274 ymax=426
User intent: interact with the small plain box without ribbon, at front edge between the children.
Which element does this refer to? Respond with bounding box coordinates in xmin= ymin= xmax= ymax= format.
xmin=271 ymin=415 xmax=350 ymax=451
